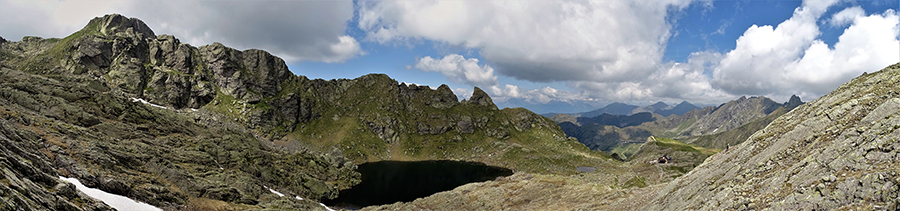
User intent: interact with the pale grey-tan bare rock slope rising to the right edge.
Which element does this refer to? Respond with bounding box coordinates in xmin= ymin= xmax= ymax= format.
xmin=645 ymin=64 xmax=900 ymax=210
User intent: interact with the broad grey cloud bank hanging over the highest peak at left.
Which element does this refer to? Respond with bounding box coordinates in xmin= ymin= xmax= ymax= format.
xmin=0 ymin=0 xmax=364 ymax=62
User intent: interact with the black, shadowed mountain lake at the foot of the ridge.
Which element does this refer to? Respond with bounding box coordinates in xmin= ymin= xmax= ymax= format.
xmin=325 ymin=160 xmax=513 ymax=209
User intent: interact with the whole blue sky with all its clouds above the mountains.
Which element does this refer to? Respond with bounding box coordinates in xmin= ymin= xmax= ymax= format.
xmin=0 ymin=0 xmax=900 ymax=113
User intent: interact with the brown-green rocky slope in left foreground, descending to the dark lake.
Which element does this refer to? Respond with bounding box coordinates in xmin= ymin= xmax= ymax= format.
xmin=0 ymin=51 xmax=359 ymax=210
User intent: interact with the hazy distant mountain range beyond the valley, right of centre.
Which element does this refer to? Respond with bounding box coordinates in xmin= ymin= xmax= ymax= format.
xmin=550 ymin=96 xmax=803 ymax=156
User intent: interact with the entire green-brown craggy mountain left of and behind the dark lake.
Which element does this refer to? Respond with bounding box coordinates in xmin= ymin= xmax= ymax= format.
xmin=0 ymin=15 xmax=611 ymax=210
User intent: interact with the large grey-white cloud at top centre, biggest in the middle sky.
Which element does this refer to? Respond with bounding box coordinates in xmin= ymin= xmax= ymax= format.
xmin=358 ymin=0 xmax=690 ymax=82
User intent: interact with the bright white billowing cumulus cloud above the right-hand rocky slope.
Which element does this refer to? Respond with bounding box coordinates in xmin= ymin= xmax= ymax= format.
xmin=712 ymin=1 xmax=900 ymax=98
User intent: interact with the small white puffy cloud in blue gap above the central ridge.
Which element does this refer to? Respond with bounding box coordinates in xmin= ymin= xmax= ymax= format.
xmin=414 ymin=54 xmax=497 ymax=87
